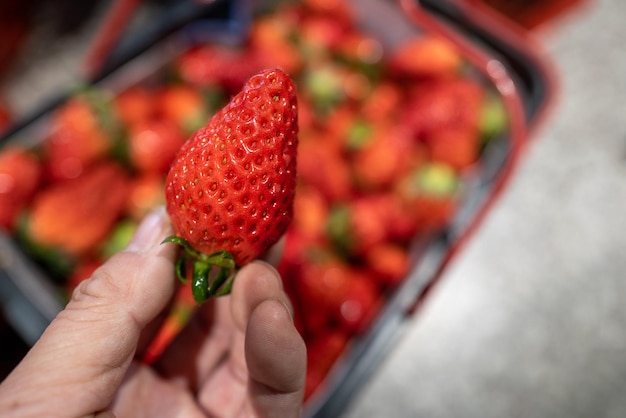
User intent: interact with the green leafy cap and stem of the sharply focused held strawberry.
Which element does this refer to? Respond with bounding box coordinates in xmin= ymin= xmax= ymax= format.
xmin=162 ymin=235 xmax=237 ymax=303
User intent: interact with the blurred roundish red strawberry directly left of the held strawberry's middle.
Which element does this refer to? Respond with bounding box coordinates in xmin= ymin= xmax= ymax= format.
xmin=128 ymin=118 xmax=187 ymax=174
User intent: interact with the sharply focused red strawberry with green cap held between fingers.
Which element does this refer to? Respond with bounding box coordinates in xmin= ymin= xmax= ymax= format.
xmin=165 ymin=69 xmax=298 ymax=302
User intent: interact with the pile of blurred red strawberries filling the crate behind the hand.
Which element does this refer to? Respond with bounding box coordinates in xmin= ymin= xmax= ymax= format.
xmin=0 ymin=0 xmax=506 ymax=404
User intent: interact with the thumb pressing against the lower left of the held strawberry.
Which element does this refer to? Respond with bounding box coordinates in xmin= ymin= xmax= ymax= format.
xmin=0 ymin=208 xmax=175 ymax=417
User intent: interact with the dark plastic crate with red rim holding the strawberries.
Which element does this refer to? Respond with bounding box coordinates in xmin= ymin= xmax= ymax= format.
xmin=0 ymin=0 xmax=554 ymax=417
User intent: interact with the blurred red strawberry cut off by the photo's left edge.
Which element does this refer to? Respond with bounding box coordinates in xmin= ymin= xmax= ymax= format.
xmin=0 ymin=147 xmax=41 ymax=231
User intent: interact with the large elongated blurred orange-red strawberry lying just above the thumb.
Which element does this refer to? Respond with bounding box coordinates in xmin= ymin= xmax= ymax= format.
xmin=25 ymin=163 xmax=128 ymax=255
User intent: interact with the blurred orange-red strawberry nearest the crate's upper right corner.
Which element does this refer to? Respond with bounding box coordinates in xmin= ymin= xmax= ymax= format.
xmin=389 ymin=35 xmax=463 ymax=77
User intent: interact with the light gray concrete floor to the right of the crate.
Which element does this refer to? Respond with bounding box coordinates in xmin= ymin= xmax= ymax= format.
xmin=345 ymin=0 xmax=626 ymax=418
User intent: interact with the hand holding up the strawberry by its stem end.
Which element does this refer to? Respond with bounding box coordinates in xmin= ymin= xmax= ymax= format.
xmin=0 ymin=210 xmax=306 ymax=418
